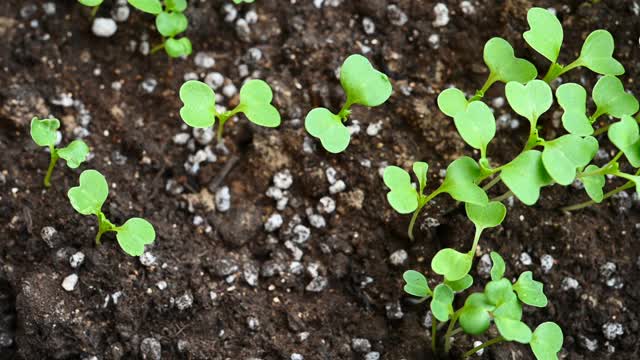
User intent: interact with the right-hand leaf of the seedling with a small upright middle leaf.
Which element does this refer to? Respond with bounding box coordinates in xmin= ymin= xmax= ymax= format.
xmin=437 ymin=156 xmax=489 ymax=205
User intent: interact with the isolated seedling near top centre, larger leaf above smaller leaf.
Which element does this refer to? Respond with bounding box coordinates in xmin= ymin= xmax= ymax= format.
xmin=304 ymin=54 xmax=393 ymax=154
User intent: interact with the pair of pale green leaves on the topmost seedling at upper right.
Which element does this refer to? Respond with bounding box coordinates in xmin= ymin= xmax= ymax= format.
xmin=523 ymin=8 xmax=624 ymax=75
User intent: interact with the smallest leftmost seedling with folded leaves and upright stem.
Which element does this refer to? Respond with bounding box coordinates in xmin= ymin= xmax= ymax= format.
xmin=31 ymin=117 xmax=89 ymax=187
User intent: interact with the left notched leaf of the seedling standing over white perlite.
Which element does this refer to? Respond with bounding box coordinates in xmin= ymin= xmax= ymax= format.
xmin=180 ymin=80 xmax=216 ymax=128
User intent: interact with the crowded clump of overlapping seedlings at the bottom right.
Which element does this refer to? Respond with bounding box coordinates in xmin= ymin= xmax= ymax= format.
xmin=403 ymin=202 xmax=563 ymax=360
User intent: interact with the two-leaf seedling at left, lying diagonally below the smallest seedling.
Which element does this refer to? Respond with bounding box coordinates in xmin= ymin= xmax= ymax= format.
xmin=67 ymin=170 xmax=156 ymax=256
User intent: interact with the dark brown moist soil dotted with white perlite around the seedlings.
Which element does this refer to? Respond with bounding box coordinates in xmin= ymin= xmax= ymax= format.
xmin=0 ymin=0 xmax=640 ymax=360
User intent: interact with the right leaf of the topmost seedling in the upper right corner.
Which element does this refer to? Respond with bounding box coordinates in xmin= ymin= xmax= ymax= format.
xmin=576 ymin=30 xmax=624 ymax=75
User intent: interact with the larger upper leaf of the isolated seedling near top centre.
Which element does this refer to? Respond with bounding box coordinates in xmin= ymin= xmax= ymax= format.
xmin=340 ymin=54 xmax=393 ymax=106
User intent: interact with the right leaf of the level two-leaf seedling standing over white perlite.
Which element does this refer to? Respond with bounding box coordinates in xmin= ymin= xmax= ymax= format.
xmin=239 ymin=80 xmax=280 ymax=127
